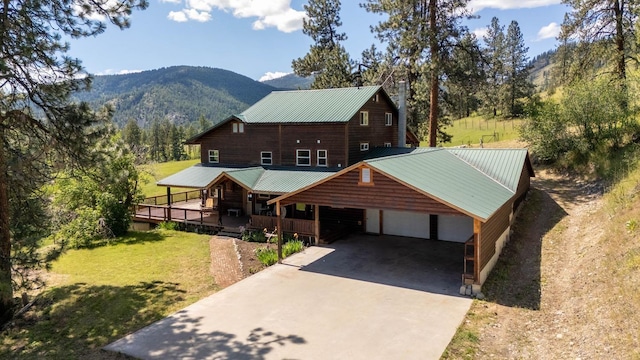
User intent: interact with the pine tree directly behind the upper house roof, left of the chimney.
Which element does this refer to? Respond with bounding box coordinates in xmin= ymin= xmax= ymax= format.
xmin=292 ymin=0 xmax=352 ymax=89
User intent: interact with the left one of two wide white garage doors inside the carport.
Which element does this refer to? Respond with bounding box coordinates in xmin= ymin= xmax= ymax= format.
xmin=382 ymin=210 xmax=429 ymax=239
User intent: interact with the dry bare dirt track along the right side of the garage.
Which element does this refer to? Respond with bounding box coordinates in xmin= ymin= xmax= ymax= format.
xmin=444 ymin=170 xmax=640 ymax=359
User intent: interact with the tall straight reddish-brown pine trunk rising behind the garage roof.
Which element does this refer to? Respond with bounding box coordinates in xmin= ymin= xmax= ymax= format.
xmin=429 ymin=0 xmax=440 ymax=147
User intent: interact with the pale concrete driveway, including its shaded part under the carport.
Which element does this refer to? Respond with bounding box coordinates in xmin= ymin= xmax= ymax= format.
xmin=105 ymin=235 xmax=471 ymax=359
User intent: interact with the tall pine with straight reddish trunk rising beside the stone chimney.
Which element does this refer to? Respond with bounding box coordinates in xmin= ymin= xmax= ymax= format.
xmin=361 ymin=0 xmax=467 ymax=146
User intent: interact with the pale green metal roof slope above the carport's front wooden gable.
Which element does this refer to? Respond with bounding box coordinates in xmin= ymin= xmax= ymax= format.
xmin=364 ymin=148 xmax=522 ymax=221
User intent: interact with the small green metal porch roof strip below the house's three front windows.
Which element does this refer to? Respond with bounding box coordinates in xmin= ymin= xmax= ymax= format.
xmin=253 ymin=170 xmax=335 ymax=195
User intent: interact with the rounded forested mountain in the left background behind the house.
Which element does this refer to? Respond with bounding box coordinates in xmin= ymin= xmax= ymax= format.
xmin=74 ymin=66 xmax=276 ymax=127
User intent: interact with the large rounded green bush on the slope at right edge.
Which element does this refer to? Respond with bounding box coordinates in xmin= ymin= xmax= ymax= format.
xmin=521 ymin=78 xmax=640 ymax=168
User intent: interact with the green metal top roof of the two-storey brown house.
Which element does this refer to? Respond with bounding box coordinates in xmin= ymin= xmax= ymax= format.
xmin=236 ymin=86 xmax=381 ymax=124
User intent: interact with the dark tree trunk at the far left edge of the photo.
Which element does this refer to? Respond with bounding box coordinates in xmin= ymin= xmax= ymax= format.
xmin=0 ymin=119 xmax=14 ymax=325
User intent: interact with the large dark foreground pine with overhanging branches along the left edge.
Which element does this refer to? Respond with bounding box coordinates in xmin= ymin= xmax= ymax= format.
xmin=0 ymin=0 xmax=147 ymax=323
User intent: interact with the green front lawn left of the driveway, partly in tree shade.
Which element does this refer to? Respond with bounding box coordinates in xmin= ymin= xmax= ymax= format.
xmin=0 ymin=230 xmax=217 ymax=359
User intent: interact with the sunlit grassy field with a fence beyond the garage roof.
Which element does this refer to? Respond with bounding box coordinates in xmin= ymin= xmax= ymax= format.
xmin=420 ymin=116 xmax=524 ymax=147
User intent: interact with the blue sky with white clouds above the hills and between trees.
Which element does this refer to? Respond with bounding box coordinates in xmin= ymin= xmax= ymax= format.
xmin=70 ymin=0 xmax=568 ymax=80
